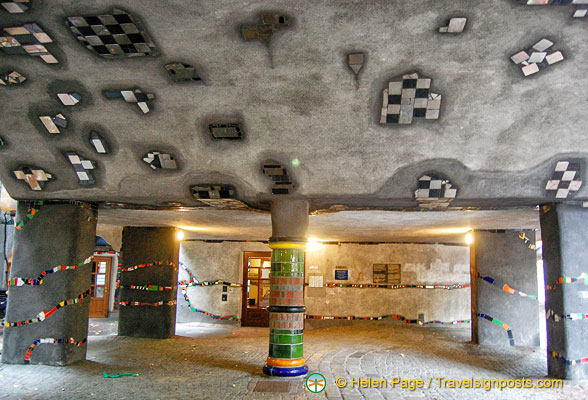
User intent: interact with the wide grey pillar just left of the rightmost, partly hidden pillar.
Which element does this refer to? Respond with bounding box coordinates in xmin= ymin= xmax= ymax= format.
xmin=470 ymin=230 xmax=540 ymax=346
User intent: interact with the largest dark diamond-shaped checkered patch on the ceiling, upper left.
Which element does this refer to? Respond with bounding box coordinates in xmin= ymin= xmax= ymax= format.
xmin=66 ymin=8 xmax=159 ymax=58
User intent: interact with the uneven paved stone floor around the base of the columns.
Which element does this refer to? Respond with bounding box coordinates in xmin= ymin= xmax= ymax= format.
xmin=0 ymin=320 xmax=588 ymax=400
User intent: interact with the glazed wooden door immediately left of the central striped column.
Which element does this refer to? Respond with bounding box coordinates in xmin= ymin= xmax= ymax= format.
xmin=241 ymin=251 xmax=272 ymax=327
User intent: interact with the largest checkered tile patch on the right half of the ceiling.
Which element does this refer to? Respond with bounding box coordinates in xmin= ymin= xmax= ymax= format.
xmin=380 ymin=73 xmax=441 ymax=124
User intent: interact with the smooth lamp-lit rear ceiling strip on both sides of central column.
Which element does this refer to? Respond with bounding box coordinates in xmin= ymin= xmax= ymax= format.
xmin=98 ymin=209 xmax=539 ymax=243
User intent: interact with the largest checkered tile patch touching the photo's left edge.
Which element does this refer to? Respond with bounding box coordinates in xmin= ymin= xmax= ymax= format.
xmin=0 ymin=23 xmax=59 ymax=64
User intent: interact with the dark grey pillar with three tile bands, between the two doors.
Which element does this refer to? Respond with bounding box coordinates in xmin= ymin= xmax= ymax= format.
xmin=118 ymin=227 xmax=180 ymax=339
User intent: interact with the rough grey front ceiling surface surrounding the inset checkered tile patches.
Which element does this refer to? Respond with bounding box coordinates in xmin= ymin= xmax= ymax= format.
xmin=0 ymin=0 xmax=588 ymax=212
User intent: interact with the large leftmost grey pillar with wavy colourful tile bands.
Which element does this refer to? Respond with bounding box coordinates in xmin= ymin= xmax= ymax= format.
xmin=2 ymin=202 xmax=96 ymax=365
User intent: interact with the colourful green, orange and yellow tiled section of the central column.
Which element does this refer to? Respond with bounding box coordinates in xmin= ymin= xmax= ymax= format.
xmin=263 ymin=241 xmax=308 ymax=377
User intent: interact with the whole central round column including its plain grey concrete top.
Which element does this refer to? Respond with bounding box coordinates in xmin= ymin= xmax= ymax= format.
xmin=263 ymin=200 xmax=308 ymax=377
